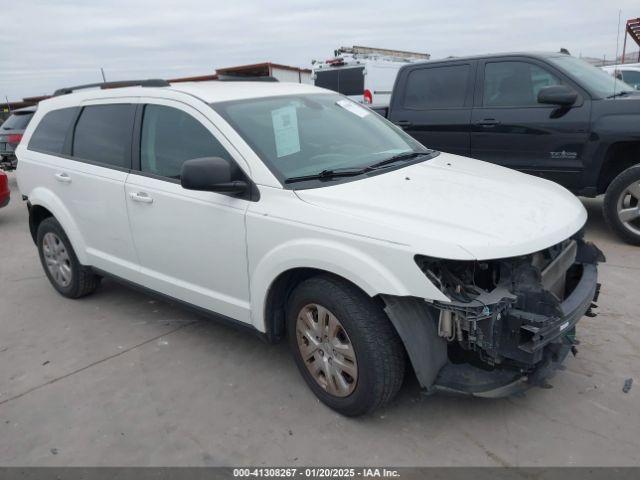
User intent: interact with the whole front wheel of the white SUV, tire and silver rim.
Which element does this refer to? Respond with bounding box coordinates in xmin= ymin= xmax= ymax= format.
xmin=287 ymin=276 xmax=405 ymax=416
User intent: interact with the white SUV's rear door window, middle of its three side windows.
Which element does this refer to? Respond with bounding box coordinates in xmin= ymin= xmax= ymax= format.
xmin=72 ymin=104 xmax=135 ymax=168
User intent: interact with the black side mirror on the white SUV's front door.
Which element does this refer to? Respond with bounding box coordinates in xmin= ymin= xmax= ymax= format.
xmin=180 ymin=157 xmax=249 ymax=194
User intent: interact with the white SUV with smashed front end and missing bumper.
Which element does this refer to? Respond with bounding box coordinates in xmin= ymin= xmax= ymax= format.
xmin=17 ymin=81 xmax=604 ymax=415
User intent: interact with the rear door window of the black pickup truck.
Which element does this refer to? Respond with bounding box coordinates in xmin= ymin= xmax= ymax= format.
xmin=404 ymin=65 xmax=470 ymax=109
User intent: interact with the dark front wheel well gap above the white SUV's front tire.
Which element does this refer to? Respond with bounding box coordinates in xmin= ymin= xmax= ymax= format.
xmin=264 ymin=268 xmax=382 ymax=342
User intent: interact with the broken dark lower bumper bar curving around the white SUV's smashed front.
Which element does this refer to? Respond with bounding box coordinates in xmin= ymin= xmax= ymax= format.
xmin=428 ymin=263 xmax=600 ymax=398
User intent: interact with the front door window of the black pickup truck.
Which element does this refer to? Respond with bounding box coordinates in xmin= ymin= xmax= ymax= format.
xmin=483 ymin=62 xmax=560 ymax=107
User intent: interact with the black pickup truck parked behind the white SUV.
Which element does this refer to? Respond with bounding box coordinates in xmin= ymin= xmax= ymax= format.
xmin=375 ymin=53 xmax=640 ymax=245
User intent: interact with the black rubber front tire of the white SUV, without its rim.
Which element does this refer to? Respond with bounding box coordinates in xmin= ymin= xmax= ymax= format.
xmin=287 ymin=275 xmax=405 ymax=417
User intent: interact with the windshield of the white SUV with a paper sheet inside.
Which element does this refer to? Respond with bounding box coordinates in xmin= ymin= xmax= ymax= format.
xmin=212 ymin=94 xmax=430 ymax=183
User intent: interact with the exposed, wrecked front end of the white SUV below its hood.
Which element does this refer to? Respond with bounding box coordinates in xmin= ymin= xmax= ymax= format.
xmin=384 ymin=234 xmax=605 ymax=398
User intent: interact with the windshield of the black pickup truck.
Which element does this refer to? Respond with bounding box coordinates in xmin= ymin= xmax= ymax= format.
xmin=549 ymin=55 xmax=634 ymax=98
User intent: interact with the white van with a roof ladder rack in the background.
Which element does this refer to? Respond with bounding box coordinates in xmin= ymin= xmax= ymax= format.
xmin=312 ymin=47 xmax=430 ymax=105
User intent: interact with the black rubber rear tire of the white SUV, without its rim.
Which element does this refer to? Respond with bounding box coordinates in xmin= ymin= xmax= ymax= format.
xmin=36 ymin=217 xmax=100 ymax=298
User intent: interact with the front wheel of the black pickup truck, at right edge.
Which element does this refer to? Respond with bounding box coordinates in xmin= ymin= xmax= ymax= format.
xmin=604 ymin=165 xmax=640 ymax=245
